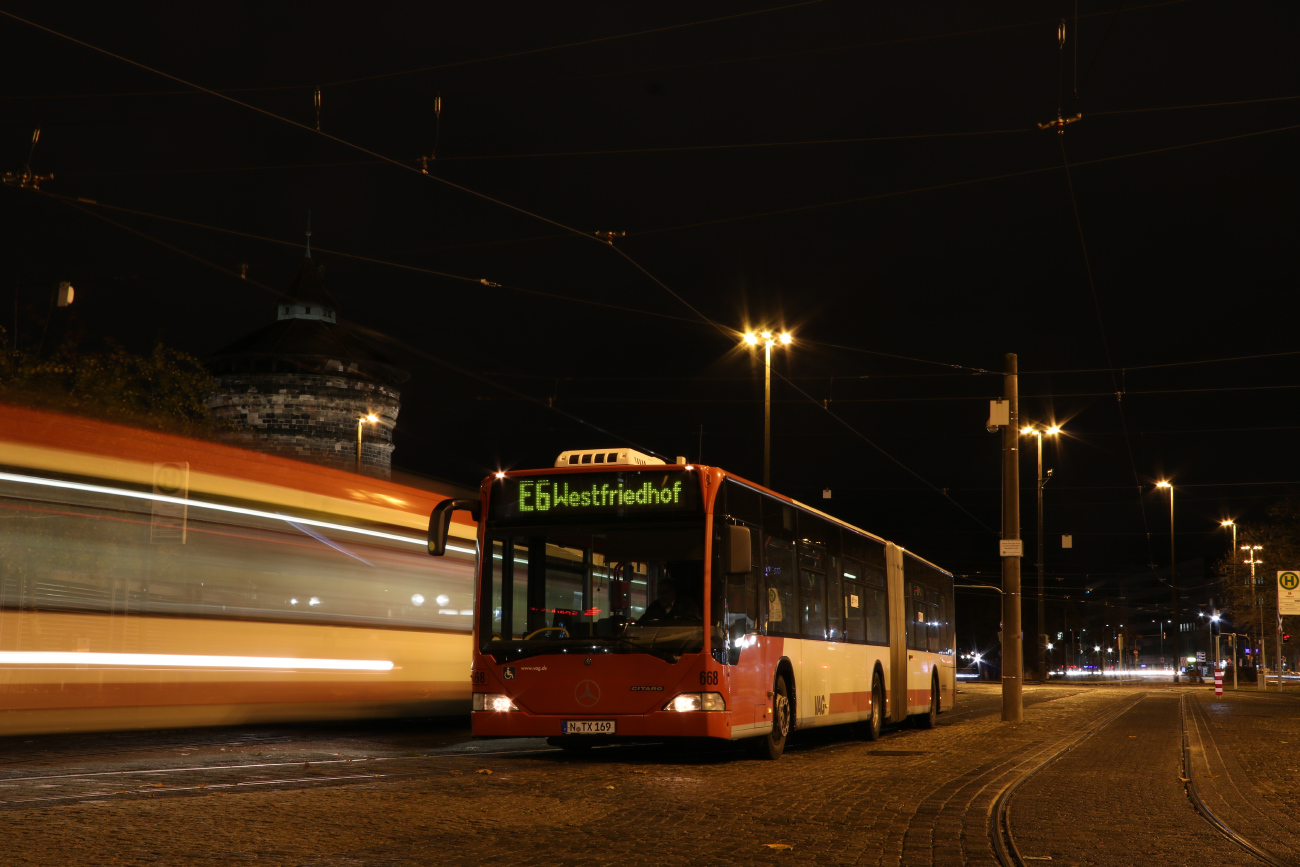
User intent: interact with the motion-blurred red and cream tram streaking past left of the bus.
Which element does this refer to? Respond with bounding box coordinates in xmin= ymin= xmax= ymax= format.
xmin=0 ymin=407 xmax=477 ymax=736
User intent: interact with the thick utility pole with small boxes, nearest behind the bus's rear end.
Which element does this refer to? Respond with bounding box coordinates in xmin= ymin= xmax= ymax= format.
xmin=1001 ymin=352 xmax=1024 ymax=723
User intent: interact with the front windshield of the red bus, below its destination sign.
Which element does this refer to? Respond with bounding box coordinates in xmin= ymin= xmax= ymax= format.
xmin=478 ymin=520 xmax=705 ymax=662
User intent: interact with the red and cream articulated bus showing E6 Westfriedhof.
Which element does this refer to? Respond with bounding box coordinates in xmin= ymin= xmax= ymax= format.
xmin=429 ymin=448 xmax=956 ymax=759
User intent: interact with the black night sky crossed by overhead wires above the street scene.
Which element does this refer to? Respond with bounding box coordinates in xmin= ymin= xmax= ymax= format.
xmin=0 ymin=0 xmax=1300 ymax=650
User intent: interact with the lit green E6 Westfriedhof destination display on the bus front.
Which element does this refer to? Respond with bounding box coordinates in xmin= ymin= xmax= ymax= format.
xmin=491 ymin=471 xmax=699 ymax=521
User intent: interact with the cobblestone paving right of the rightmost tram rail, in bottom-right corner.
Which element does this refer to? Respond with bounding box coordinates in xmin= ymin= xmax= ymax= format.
xmin=1187 ymin=690 xmax=1300 ymax=863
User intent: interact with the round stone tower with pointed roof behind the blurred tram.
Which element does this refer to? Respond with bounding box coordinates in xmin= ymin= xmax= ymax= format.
xmin=205 ymin=244 xmax=410 ymax=478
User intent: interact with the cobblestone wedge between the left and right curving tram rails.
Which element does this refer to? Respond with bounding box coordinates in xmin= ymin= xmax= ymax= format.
xmin=1011 ymin=690 xmax=1260 ymax=867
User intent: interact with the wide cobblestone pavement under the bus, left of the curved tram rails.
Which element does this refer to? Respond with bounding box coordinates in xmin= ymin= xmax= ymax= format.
xmin=0 ymin=684 xmax=1289 ymax=867
